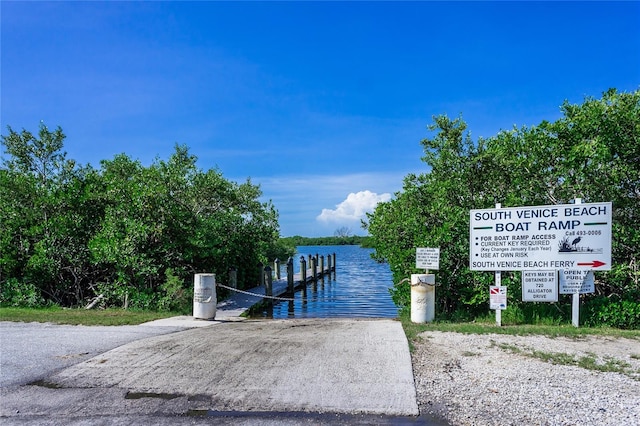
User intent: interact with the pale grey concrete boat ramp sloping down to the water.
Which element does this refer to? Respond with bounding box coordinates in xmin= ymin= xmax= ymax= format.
xmin=0 ymin=282 xmax=434 ymax=424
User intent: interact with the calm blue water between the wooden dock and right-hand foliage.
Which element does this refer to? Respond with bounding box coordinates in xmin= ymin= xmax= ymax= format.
xmin=252 ymin=246 xmax=398 ymax=319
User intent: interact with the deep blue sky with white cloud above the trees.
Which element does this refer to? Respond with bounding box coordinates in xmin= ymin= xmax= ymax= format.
xmin=0 ymin=0 xmax=640 ymax=236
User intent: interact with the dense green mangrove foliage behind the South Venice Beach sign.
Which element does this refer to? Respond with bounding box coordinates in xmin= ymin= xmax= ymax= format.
xmin=365 ymin=89 xmax=640 ymax=328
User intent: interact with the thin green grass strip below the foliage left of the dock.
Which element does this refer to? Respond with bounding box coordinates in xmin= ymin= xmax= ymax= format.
xmin=0 ymin=307 xmax=178 ymax=325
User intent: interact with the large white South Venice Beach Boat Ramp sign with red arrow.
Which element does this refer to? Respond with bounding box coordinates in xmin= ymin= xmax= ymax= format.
xmin=469 ymin=203 xmax=611 ymax=271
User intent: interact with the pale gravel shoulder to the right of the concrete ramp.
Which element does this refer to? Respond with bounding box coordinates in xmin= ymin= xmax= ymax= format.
xmin=412 ymin=331 xmax=640 ymax=425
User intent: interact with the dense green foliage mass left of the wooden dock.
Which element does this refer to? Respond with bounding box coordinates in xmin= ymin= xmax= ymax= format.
xmin=0 ymin=123 xmax=286 ymax=310
